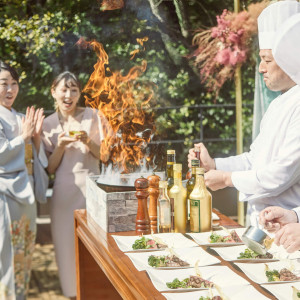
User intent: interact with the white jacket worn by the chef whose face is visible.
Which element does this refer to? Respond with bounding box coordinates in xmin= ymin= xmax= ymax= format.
xmin=215 ymin=85 xmax=300 ymax=226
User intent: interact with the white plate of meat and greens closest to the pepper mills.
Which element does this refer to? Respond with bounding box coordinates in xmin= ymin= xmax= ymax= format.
xmin=112 ymin=233 xmax=198 ymax=252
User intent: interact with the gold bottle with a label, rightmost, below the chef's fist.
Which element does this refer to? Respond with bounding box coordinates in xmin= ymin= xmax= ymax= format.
xmin=190 ymin=168 xmax=212 ymax=232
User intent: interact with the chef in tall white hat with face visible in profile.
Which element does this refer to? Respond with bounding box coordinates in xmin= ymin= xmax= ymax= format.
xmin=188 ymin=1 xmax=300 ymax=226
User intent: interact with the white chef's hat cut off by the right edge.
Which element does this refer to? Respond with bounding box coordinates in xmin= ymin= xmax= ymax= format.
xmin=272 ymin=13 xmax=300 ymax=85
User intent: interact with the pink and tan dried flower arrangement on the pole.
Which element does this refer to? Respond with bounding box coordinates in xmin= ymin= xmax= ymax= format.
xmin=190 ymin=0 xmax=268 ymax=95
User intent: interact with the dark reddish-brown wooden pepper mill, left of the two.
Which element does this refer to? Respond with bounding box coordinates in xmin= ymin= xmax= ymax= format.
xmin=134 ymin=177 xmax=151 ymax=235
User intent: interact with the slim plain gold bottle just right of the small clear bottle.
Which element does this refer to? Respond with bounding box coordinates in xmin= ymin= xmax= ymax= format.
xmin=169 ymin=164 xmax=186 ymax=233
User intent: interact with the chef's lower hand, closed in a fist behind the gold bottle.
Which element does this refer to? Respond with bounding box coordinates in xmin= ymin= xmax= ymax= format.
xmin=204 ymin=170 xmax=233 ymax=191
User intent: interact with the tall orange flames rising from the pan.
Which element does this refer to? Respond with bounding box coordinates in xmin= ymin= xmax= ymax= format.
xmin=78 ymin=40 xmax=155 ymax=173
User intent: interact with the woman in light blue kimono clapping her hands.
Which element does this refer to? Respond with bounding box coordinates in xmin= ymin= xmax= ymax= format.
xmin=0 ymin=61 xmax=48 ymax=299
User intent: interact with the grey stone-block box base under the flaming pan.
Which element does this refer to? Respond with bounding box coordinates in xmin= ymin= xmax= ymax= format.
xmin=86 ymin=176 xmax=138 ymax=232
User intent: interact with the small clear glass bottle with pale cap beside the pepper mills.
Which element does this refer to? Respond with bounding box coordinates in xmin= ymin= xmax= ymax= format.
xmin=157 ymin=180 xmax=171 ymax=233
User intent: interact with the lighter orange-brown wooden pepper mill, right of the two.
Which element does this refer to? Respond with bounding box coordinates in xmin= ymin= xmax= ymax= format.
xmin=147 ymin=173 xmax=160 ymax=233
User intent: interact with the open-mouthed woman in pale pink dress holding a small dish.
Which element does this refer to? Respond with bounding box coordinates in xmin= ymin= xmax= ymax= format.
xmin=43 ymin=72 xmax=105 ymax=299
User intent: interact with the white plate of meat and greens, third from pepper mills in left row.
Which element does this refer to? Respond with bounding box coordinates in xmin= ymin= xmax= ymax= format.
xmin=147 ymin=266 xmax=249 ymax=292
